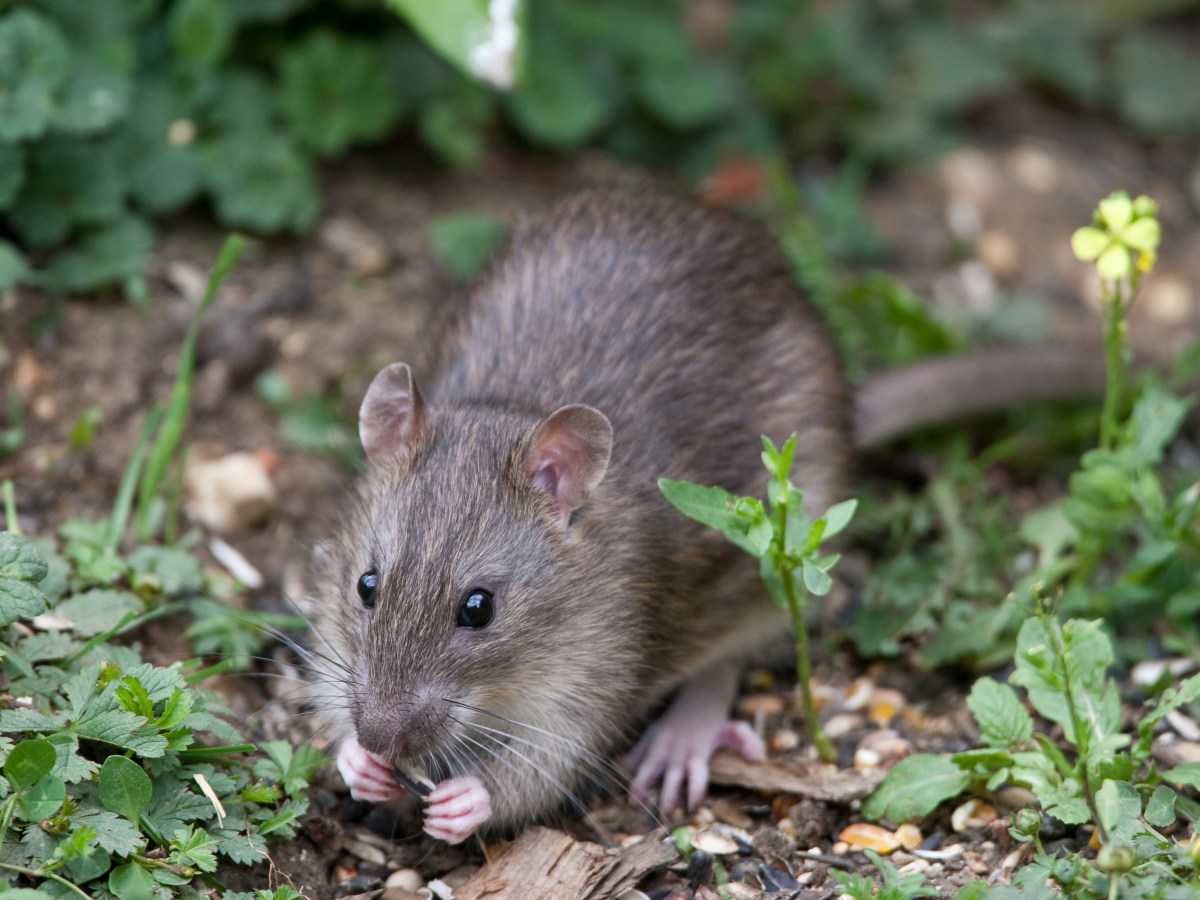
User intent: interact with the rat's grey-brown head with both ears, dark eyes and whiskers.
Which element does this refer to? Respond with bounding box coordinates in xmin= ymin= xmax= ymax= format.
xmin=322 ymin=364 xmax=629 ymax=815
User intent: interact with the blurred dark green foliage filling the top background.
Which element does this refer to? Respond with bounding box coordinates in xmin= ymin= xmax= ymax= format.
xmin=0 ymin=0 xmax=1200 ymax=292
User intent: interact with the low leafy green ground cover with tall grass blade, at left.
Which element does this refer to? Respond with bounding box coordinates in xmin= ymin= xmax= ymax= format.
xmin=0 ymin=239 xmax=325 ymax=900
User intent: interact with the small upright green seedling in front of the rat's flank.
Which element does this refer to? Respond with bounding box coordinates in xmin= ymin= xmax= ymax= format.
xmin=659 ymin=433 xmax=858 ymax=762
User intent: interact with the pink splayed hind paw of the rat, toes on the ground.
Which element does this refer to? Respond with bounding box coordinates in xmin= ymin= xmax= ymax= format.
xmin=625 ymin=710 xmax=766 ymax=812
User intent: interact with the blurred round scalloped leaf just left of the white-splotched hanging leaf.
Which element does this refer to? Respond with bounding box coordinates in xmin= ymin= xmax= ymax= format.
xmin=280 ymin=31 xmax=408 ymax=156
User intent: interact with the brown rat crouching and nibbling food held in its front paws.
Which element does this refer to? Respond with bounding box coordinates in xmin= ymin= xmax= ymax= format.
xmin=313 ymin=191 xmax=1104 ymax=841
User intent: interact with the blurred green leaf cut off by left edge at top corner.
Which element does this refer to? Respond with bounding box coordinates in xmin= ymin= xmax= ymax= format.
xmin=0 ymin=8 xmax=71 ymax=143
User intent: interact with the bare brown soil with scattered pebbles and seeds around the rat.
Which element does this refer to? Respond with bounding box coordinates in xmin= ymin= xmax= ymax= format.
xmin=0 ymin=95 xmax=1200 ymax=898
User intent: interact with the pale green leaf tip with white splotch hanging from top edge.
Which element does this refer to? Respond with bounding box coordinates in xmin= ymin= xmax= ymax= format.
xmin=386 ymin=0 xmax=524 ymax=88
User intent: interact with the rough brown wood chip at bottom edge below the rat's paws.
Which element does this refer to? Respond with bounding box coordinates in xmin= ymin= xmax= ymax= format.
xmin=455 ymin=828 xmax=678 ymax=900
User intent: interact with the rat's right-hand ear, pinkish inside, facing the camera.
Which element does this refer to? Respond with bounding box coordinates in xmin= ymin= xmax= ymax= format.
xmin=524 ymin=406 xmax=612 ymax=526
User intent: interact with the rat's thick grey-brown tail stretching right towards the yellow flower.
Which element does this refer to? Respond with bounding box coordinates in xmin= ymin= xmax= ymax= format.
xmin=854 ymin=343 xmax=1104 ymax=449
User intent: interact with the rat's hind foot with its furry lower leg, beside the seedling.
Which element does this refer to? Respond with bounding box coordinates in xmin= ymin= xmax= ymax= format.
xmin=625 ymin=664 xmax=766 ymax=812
